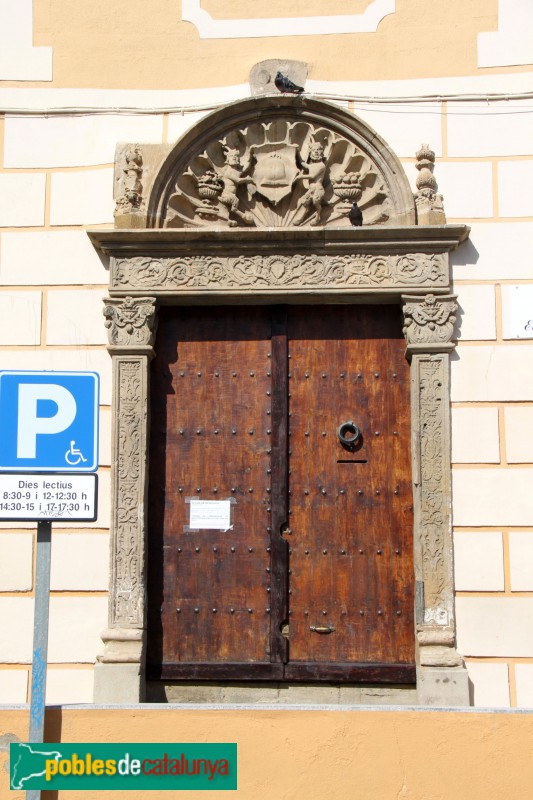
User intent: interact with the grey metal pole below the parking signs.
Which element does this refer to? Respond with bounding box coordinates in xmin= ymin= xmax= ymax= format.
xmin=26 ymin=521 xmax=52 ymax=800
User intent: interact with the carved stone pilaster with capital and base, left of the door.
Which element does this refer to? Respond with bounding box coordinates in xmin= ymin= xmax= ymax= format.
xmin=95 ymin=297 xmax=155 ymax=702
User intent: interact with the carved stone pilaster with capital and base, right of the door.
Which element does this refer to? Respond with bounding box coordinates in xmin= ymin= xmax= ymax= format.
xmin=402 ymin=294 xmax=468 ymax=705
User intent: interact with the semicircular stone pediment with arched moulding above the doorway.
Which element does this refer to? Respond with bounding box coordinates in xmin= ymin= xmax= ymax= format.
xmin=147 ymin=95 xmax=416 ymax=229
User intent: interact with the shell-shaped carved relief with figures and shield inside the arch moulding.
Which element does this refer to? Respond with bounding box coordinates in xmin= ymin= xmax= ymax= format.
xmin=162 ymin=120 xmax=393 ymax=228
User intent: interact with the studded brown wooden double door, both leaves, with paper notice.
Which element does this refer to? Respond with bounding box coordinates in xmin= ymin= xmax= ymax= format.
xmin=147 ymin=305 xmax=415 ymax=683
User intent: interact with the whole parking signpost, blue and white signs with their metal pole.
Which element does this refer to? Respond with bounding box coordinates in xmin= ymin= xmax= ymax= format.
xmin=0 ymin=370 xmax=100 ymax=800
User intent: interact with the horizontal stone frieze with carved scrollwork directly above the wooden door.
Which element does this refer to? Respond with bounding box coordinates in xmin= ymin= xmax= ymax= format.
xmin=108 ymin=253 xmax=448 ymax=294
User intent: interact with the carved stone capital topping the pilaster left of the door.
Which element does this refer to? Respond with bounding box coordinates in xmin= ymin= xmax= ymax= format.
xmin=103 ymin=297 xmax=156 ymax=348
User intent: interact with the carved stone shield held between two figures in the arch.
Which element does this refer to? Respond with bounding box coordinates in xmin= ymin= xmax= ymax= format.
xmin=250 ymin=142 xmax=299 ymax=205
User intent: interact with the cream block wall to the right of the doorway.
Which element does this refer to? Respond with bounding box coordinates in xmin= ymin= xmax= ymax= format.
xmin=439 ymin=109 xmax=533 ymax=708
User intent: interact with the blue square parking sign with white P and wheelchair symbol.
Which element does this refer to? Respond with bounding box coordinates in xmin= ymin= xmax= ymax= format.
xmin=0 ymin=371 xmax=99 ymax=472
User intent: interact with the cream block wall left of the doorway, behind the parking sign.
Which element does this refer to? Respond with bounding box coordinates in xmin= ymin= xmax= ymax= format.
xmin=0 ymin=111 xmax=124 ymax=704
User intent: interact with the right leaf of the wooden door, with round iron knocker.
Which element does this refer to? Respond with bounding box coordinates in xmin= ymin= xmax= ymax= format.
xmin=289 ymin=306 xmax=414 ymax=666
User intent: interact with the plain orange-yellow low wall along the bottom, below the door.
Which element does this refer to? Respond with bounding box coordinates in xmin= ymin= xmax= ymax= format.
xmin=0 ymin=707 xmax=533 ymax=800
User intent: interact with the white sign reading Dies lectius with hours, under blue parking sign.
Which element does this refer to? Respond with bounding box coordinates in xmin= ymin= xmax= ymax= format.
xmin=0 ymin=473 xmax=98 ymax=522
